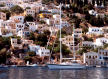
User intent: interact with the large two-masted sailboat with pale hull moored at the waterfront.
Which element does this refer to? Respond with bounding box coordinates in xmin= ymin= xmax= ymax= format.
xmin=47 ymin=4 xmax=86 ymax=69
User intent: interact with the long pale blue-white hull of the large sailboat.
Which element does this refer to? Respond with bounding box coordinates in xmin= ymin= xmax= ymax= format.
xmin=47 ymin=64 xmax=86 ymax=69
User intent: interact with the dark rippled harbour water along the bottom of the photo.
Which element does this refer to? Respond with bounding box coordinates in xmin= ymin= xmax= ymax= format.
xmin=0 ymin=67 xmax=108 ymax=79
